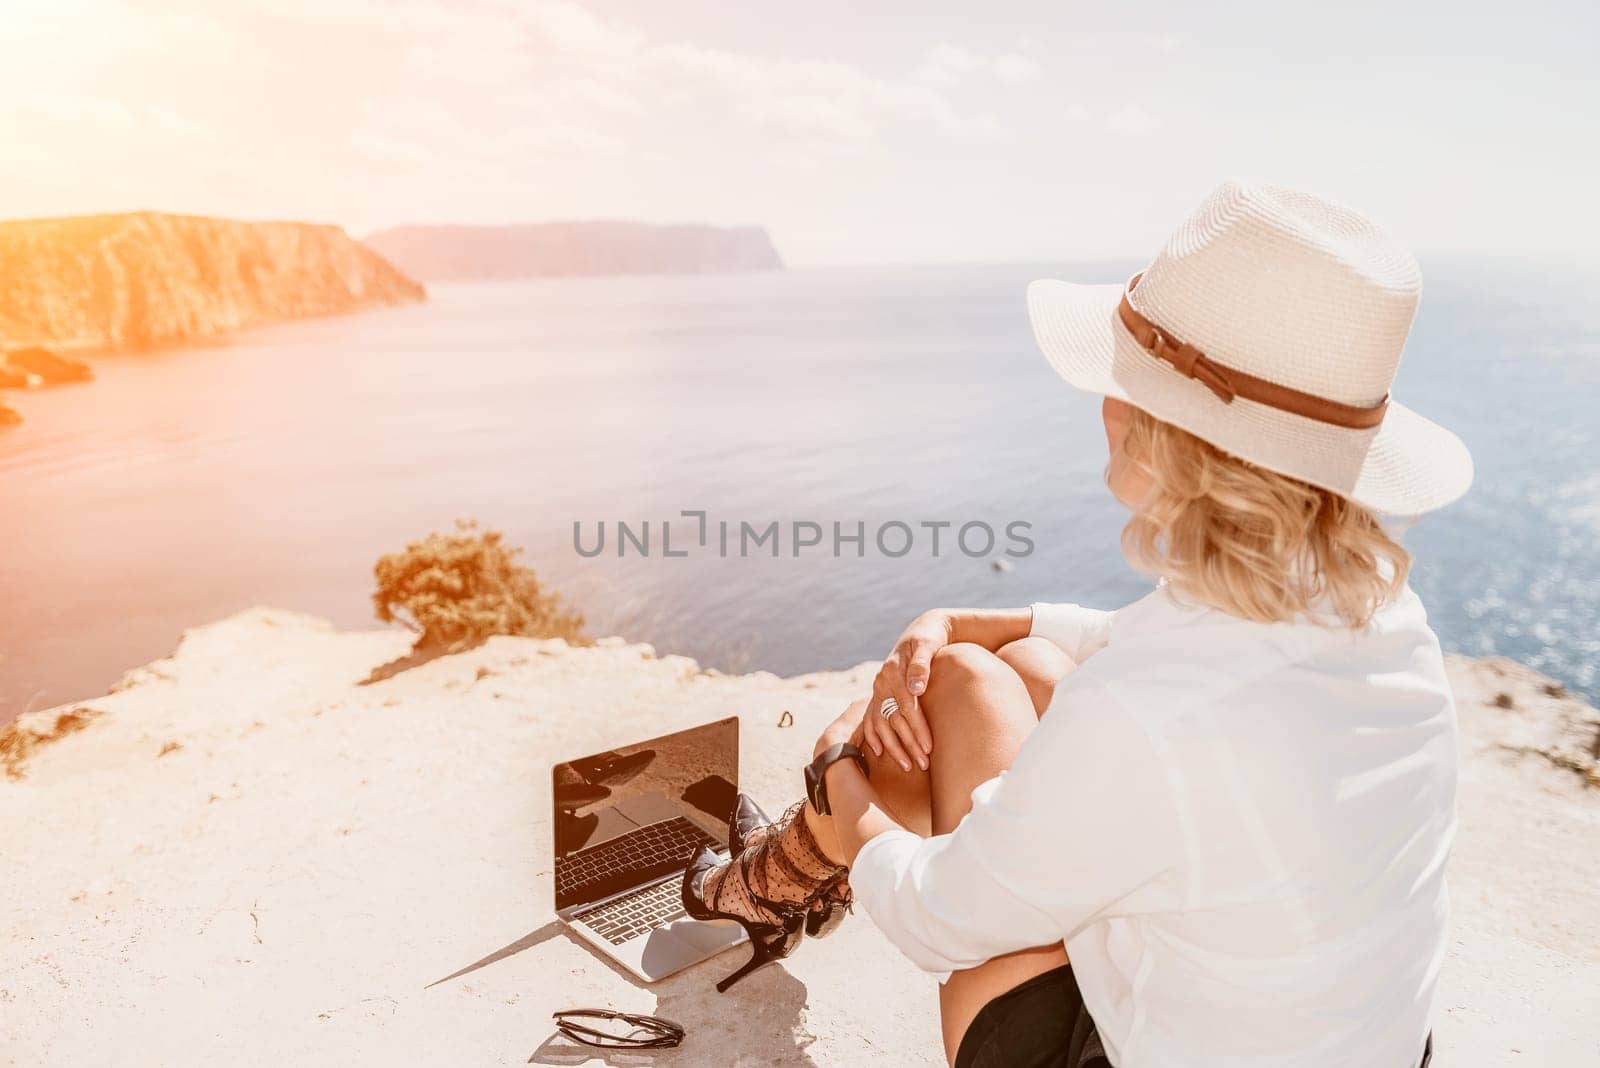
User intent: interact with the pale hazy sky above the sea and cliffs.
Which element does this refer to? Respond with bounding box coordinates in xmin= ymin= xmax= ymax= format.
xmin=0 ymin=0 xmax=1600 ymax=265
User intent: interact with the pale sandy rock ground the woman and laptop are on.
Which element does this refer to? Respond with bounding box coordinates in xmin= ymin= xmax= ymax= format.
xmin=0 ymin=609 xmax=1600 ymax=1068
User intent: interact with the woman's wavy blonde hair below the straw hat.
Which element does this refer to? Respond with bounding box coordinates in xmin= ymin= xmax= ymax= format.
xmin=1122 ymin=408 xmax=1411 ymax=628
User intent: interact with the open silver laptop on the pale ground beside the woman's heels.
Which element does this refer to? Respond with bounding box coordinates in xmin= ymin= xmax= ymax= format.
xmin=550 ymin=716 xmax=746 ymax=983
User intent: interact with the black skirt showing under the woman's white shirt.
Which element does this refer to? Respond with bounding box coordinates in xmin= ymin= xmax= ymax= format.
xmin=955 ymin=964 xmax=1110 ymax=1068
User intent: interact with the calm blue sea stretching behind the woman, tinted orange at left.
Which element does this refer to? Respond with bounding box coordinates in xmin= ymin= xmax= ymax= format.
xmin=0 ymin=261 xmax=1600 ymax=719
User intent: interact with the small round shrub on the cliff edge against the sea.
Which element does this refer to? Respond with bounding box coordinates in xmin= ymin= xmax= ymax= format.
xmin=373 ymin=520 xmax=584 ymax=652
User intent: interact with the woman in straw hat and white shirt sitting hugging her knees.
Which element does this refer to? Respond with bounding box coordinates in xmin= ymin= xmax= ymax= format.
xmin=685 ymin=184 xmax=1472 ymax=1068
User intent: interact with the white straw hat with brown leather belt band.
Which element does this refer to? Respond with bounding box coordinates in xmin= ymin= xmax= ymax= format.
xmin=1027 ymin=182 xmax=1472 ymax=515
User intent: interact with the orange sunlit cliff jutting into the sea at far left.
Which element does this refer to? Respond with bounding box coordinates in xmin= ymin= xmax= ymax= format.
xmin=0 ymin=211 xmax=424 ymax=349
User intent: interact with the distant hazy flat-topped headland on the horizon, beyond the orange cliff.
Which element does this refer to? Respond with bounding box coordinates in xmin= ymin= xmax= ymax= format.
xmin=366 ymin=222 xmax=784 ymax=281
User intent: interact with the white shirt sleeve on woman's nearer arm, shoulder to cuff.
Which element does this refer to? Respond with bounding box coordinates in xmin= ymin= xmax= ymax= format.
xmin=850 ymin=678 xmax=1186 ymax=982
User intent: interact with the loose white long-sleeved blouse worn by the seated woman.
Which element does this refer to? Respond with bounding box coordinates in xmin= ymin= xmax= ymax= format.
xmin=850 ymin=587 xmax=1456 ymax=1068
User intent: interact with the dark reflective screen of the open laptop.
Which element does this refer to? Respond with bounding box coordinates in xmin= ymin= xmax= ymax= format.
xmin=550 ymin=718 xmax=739 ymax=910
